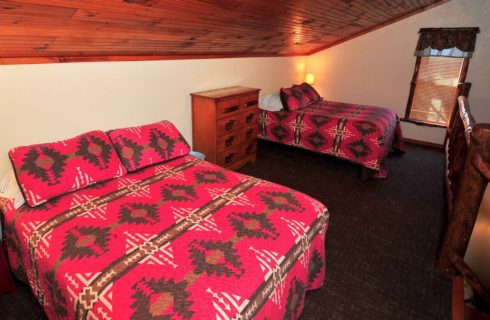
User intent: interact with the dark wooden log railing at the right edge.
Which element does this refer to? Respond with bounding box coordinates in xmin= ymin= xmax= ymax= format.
xmin=437 ymin=96 xmax=490 ymax=274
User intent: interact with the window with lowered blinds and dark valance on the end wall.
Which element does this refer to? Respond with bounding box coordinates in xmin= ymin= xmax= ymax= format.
xmin=405 ymin=28 xmax=478 ymax=127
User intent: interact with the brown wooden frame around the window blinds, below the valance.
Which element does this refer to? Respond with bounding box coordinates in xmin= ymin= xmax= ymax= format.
xmin=403 ymin=56 xmax=470 ymax=128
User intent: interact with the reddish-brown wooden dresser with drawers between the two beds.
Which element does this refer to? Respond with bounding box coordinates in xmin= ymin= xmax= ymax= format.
xmin=191 ymin=87 xmax=260 ymax=170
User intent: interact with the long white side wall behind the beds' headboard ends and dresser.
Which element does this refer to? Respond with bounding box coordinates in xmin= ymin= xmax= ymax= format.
xmin=0 ymin=57 xmax=305 ymax=175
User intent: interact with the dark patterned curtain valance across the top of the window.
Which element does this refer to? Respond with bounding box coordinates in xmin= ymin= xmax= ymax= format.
xmin=415 ymin=28 xmax=480 ymax=58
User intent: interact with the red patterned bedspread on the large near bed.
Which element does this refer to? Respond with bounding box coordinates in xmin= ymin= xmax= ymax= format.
xmin=3 ymin=156 xmax=328 ymax=319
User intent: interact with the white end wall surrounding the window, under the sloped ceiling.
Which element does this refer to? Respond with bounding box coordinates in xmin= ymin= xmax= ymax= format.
xmin=307 ymin=0 xmax=490 ymax=143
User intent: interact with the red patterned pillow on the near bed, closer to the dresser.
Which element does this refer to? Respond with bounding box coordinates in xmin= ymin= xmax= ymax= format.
xmin=109 ymin=121 xmax=191 ymax=172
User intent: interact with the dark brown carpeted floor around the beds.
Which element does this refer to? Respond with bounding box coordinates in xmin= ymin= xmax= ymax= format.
xmin=0 ymin=141 xmax=451 ymax=320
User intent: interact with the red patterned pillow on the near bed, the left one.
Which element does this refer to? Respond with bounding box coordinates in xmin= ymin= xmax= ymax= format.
xmin=9 ymin=131 xmax=126 ymax=207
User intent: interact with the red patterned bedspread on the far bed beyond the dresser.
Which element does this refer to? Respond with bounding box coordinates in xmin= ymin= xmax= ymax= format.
xmin=258 ymin=100 xmax=404 ymax=178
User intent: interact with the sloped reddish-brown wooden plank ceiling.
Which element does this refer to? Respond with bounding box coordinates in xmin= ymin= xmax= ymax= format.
xmin=0 ymin=0 xmax=448 ymax=63
